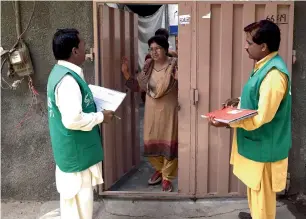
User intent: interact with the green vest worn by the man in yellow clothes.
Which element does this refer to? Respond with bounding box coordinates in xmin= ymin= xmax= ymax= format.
xmin=237 ymin=55 xmax=292 ymax=162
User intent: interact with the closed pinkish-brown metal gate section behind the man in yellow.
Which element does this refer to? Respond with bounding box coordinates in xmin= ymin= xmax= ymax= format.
xmin=179 ymin=2 xmax=294 ymax=197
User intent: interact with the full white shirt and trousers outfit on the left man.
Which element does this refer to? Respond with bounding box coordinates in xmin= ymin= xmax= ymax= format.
xmin=43 ymin=61 xmax=104 ymax=219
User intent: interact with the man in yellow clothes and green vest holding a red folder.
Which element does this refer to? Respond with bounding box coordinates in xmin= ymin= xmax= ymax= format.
xmin=209 ymin=20 xmax=291 ymax=219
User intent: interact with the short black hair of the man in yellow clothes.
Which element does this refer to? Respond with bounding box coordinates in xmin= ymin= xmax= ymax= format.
xmin=244 ymin=20 xmax=281 ymax=52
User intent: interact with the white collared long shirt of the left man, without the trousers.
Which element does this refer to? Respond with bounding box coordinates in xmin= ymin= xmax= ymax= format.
xmin=55 ymin=60 xmax=104 ymax=199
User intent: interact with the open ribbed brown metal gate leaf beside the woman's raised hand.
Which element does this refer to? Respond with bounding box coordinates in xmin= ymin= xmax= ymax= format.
xmin=96 ymin=5 xmax=140 ymax=189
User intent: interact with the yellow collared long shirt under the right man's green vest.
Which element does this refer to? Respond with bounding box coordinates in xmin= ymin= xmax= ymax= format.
xmin=230 ymin=52 xmax=288 ymax=192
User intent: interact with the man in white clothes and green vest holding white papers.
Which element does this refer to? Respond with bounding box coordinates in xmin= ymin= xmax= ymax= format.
xmin=47 ymin=29 xmax=114 ymax=219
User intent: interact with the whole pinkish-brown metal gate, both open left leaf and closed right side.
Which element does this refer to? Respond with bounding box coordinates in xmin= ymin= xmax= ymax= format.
xmin=94 ymin=0 xmax=294 ymax=197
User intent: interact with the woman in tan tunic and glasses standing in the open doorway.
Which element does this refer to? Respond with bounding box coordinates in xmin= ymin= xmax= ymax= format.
xmin=122 ymin=36 xmax=179 ymax=192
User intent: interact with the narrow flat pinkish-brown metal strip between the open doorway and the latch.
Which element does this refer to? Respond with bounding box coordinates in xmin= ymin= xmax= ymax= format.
xmin=178 ymin=2 xmax=195 ymax=195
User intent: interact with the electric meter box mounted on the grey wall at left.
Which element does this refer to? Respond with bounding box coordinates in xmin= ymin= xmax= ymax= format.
xmin=10 ymin=42 xmax=34 ymax=77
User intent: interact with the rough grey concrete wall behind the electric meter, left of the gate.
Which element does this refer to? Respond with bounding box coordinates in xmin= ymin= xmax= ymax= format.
xmin=1 ymin=1 xmax=94 ymax=200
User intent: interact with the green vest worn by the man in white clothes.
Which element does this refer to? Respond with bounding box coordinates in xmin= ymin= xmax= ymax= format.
xmin=47 ymin=65 xmax=103 ymax=173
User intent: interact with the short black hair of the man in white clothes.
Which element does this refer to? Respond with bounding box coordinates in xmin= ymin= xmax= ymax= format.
xmin=52 ymin=28 xmax=80 ymax=60
